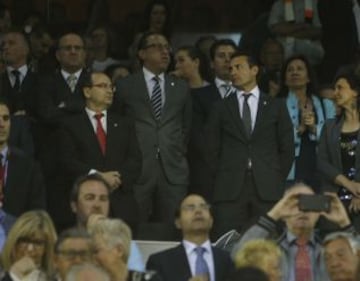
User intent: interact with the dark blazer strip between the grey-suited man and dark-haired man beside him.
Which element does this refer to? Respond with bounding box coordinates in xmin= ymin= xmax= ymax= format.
xmin=187 ymin=84 xmax=221 ymax=200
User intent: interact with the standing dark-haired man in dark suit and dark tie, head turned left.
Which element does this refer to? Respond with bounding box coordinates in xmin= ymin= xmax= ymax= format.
xmin=207 ymin=52 xmax=294 ymax=236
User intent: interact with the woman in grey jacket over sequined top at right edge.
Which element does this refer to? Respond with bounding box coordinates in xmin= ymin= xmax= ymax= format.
xmin=318 ymin=70 xmax=360 ymax=230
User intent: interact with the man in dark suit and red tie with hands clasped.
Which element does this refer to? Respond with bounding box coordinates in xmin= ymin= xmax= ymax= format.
xmin=57 ymin=72 xmax=141 ymax=232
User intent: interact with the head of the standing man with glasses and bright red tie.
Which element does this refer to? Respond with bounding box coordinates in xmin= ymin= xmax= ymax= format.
xmin=84 ymin=73 xmax=114 ymax=112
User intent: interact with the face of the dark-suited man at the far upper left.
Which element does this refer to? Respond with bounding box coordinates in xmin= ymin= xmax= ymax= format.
xmin=2 ymin=32 xmax=29 ymax=67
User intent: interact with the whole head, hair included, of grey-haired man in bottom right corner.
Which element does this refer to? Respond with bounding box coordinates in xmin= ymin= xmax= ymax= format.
xmin=323 ymin=232 xmax=360 ymax=281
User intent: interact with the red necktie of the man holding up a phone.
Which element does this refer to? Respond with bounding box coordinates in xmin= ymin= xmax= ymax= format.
xmin=295 ymin=239 xmax=312 ymax=281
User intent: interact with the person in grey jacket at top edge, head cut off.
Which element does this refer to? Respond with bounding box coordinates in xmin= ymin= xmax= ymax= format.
xmin=268 ymin=0 xmax=324 ymax=65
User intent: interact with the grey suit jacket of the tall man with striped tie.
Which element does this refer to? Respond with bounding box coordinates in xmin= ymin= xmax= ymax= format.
xmin=115 ymin=71 xmax=192 ymax=184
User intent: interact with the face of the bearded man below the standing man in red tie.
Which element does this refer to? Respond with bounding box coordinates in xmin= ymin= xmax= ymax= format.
xmin=71 ymin=178 xmax=109 ymax=225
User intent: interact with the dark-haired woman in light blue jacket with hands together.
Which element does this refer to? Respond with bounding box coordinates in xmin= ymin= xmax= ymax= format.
xmin=278 ymin=55 xmax=335 ymax=188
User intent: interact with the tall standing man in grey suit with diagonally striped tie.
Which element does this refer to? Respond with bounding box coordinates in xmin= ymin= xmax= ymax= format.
xmin=117 ymin=32 xmax=192 ymax=232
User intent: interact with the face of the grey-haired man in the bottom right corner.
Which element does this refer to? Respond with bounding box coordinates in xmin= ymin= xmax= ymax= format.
xmin=325 ymin=238 xmax=359 ymax=281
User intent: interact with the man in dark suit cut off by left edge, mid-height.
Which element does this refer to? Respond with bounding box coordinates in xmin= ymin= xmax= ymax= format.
xmin=0 ymin=100 xmax=45 ymax=224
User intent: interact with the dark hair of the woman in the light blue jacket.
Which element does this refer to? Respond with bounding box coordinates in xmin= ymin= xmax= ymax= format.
xmin=278 ymin=55 xmax=317 ymax=97
